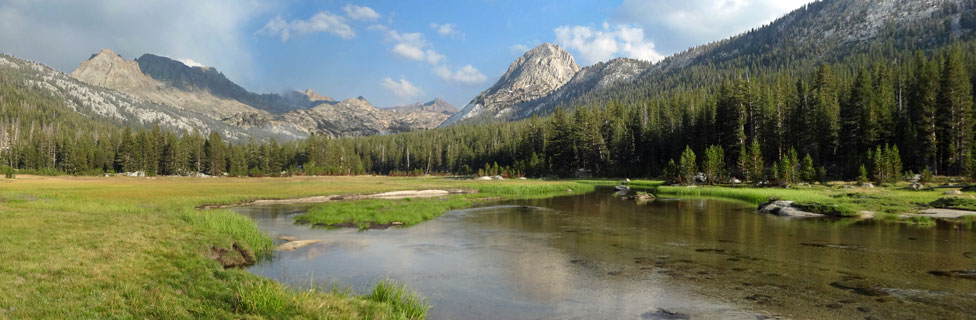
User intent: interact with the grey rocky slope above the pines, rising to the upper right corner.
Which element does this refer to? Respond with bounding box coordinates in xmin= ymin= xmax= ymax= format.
xmin=549 ymin=0 xmax=976 ymax=115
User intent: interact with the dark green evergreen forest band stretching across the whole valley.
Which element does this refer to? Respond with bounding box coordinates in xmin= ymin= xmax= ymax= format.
xmin=0 ymin=43 xmax=976 ymax=183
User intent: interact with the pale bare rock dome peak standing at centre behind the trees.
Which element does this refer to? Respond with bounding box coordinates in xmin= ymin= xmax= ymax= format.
xmin=442 ymin=43 xmax=580 ymax=126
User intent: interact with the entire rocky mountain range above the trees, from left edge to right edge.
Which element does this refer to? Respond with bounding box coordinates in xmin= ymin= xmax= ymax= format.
xmin=0 ymin=0 xmax=976 ymax=140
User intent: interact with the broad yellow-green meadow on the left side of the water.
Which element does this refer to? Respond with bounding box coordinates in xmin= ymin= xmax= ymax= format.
xmin=0 ymin=175 xmax=604 ymax=319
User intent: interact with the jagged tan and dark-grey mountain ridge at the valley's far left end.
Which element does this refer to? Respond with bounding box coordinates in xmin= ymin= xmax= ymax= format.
xmin=71 ymin=49 xmax=456 ymax=137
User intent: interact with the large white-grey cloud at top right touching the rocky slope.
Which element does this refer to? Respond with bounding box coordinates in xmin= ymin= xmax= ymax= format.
xmin=612 ymin=0 xmax=812 ymax=51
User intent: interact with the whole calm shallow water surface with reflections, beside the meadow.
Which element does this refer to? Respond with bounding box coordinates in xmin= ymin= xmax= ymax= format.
xmin=236 ymin=192 xmax=976 ymax=319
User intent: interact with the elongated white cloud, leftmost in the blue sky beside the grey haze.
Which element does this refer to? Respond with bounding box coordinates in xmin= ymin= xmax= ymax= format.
xmin=258 ymin=11 xmax=356 ymax=42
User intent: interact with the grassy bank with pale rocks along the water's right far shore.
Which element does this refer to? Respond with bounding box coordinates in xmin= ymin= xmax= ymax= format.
xmin=631 ymin=180 xmax=976 ymax=222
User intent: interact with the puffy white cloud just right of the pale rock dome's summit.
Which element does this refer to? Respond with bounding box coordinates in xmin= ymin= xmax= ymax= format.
xmin=555 ymin=23 xmax=664 ymax=64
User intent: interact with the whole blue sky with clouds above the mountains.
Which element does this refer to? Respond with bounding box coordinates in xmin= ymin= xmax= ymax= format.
xmin=0 ymin=0 xmax=810 ymax=108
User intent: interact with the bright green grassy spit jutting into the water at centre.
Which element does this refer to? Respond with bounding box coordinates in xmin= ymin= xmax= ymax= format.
xmin=295 ymin=180 xmax=613 ymax=229
